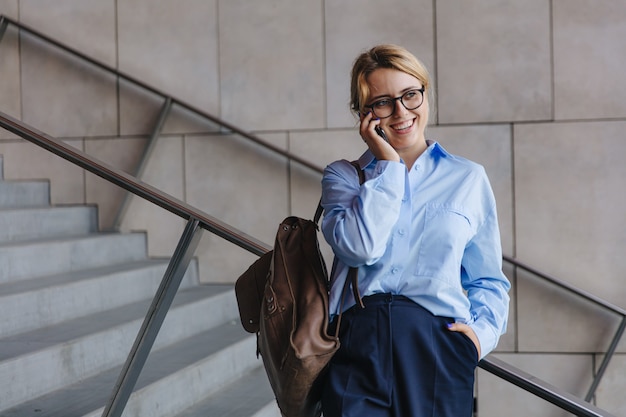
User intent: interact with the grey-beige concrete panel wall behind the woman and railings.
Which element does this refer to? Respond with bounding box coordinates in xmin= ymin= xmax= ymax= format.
xmin=0 ymin=0 xmax=626 ymax=416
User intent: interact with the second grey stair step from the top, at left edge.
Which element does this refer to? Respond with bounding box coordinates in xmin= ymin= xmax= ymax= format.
xmin=0 ymin=206 xmax=98 ymax=242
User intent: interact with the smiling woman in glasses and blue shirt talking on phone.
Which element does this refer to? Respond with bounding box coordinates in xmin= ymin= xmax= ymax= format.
xmin=322 ymin=45 xmax=510 ymax=417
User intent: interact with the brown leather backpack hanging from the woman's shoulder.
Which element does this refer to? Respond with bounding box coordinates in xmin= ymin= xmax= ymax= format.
xmin=235 ymin=160 xmax=363 ymax=417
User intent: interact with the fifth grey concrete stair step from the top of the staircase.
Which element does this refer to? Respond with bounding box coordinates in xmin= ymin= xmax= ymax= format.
xmin=0 ymin=285 xmax=236 ymax=415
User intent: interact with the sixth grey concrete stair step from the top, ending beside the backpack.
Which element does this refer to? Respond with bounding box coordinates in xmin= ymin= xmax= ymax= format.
xmin=2 ymin=321 xmax=258 ymax=417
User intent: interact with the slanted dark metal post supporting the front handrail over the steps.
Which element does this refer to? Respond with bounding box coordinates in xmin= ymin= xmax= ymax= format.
xmin=102 ymin=218 xmax=202 ymax=417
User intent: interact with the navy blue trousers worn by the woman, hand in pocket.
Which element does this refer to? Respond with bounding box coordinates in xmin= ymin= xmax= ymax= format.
xmin=322 ymin=294 xmax=478 ymax=417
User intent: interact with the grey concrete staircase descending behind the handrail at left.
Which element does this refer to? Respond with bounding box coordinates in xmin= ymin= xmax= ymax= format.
xmin=0 ymin=157 xmax=280 ymax=417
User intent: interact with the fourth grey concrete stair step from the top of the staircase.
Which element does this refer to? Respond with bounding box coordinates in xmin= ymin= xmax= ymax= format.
xmin=0 ymin=259 xmax=198 ymax=337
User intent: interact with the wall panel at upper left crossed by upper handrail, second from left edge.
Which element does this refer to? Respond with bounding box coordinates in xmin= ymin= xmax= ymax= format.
xmin=20 ymin=0 xmax=117 ymax=137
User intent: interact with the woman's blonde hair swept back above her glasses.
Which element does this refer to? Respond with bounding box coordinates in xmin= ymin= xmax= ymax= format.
xmin=350 ymin=44 xmax=431 ymax=114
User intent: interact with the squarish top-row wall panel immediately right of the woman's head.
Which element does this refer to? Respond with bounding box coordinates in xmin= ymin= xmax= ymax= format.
xmin=436 ymin=0 xmax=552 ymax=123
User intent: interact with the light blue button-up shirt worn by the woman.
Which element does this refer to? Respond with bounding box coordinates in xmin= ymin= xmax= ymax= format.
xmin=322 ymin=141 xmax=510 ymax=357
